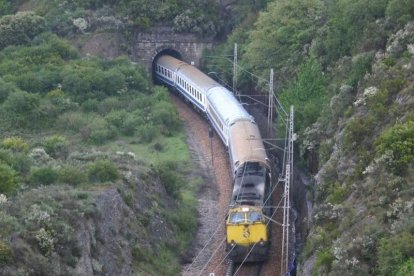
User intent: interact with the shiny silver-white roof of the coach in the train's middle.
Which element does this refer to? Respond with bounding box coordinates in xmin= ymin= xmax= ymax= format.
xmin=207 ymin=87 xmax=254 ymax=126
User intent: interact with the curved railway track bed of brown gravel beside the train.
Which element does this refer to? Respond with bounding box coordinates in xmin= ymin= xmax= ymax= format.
xmin=171 ymin=93 xmax=283 ymax=276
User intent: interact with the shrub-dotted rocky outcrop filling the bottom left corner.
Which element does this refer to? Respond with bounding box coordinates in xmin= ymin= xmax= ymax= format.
xmin=0 ymin=151 xmax=179 ymax=275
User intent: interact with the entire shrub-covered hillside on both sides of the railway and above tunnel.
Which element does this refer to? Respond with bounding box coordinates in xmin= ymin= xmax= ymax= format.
xmin=0 ymin=0 xmax=414 ymax=275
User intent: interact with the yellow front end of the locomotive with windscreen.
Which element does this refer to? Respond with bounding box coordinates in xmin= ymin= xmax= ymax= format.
xmin=226 ymin=206 xmax=270 ymax=262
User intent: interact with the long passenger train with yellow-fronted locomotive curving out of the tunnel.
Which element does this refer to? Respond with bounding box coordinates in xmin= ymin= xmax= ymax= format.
xmin=153 ymin=55 xmax=271 ymax=263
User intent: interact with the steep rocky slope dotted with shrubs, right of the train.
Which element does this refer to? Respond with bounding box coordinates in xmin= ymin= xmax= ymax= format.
xmin=300 ymin=22 xmax=414 ymax=275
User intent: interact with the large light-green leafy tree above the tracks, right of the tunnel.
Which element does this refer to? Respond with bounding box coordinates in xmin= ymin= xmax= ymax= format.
xmin=243 ymin=0 xmax=324 ymax=84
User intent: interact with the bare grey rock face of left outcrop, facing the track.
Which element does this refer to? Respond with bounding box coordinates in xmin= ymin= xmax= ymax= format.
xmin=75 ymin=154 xmax=174 ymax=275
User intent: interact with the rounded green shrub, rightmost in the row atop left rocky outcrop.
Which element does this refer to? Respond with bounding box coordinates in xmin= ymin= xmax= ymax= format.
xmin=88 ymin=160 xmax=119 ymax=182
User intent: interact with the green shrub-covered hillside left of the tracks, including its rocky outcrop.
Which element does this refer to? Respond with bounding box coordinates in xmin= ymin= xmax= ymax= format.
xmin=0 ymin=1 xmax=207 ymax=275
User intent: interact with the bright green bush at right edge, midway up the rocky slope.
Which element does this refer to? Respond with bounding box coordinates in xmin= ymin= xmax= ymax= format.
xmin=375 ymin=120 xmax=414 ymax=173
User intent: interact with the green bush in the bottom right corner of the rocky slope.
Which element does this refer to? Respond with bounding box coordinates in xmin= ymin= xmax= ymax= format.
xmin=378 ymin=232 xmax=414 ymax=276
